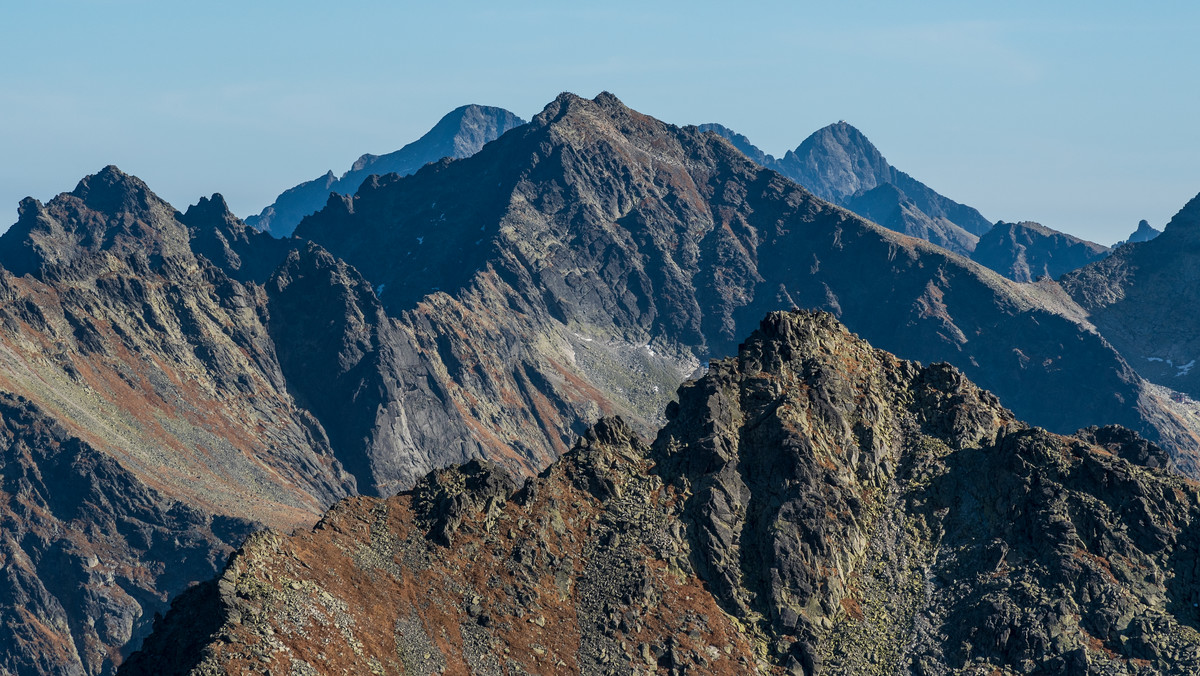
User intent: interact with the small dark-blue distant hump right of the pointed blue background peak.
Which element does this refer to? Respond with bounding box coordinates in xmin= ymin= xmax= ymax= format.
xmin=971 ymin=221 xmax=1111 ymax=282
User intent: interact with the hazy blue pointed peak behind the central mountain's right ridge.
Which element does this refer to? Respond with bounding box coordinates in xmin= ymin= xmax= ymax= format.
xmin=700 ymin=122 xmax=991 ymax=256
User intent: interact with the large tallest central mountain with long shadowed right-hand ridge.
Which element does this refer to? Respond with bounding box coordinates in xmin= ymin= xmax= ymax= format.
xmin=296 ymin=94 xmax=1195 ymax=477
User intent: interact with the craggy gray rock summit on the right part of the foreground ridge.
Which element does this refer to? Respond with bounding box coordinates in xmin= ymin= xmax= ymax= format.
xmin=654 ymin=315 xmax=1200 ymax=674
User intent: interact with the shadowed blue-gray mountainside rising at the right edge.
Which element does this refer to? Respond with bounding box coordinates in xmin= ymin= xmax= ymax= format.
xmin=1062 ymin=196 xmax=1200 ymax=397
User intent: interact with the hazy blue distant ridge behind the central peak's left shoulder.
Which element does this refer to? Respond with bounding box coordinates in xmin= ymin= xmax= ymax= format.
xmin=246 ymin=106 xmax=524 ymax=238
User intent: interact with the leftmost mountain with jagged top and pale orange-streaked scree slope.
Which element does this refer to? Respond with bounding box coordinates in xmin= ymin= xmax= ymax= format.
xmin=0 ymin=167 xmax=355 ymax=674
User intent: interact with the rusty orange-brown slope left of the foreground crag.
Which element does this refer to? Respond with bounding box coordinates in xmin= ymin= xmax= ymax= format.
xmin=122 ymin=420 xmax=757 ymax=674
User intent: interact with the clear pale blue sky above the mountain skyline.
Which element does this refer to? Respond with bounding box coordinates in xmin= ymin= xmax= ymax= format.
xmin=0 ymin=0 xmax=1200 ymax=244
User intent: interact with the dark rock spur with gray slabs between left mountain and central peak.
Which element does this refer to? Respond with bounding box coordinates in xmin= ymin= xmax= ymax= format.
xmin=266 ymin=243 xmax=487 ymax=496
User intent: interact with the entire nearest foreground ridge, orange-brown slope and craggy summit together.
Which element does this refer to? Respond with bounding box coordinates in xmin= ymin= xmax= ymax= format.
xmin=121 ymin=312 xmax=1200 ymax=675
